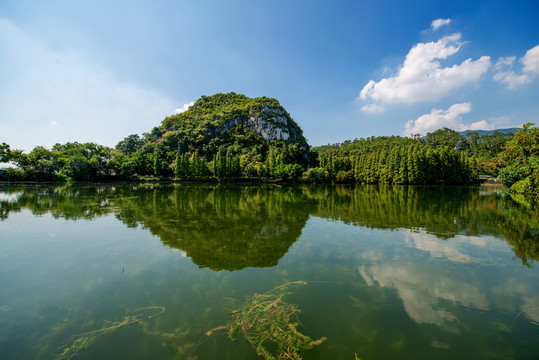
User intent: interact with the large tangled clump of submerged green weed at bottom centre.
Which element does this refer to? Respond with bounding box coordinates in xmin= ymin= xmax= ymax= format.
xmin=206 ymin=281 xmax=326 ymax=360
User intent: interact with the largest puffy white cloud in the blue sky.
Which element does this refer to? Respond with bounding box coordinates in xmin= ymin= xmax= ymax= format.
xmin=359 ymin=33 xmax=490 ymax=104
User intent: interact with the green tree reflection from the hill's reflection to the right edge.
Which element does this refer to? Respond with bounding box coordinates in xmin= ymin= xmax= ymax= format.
xmin=307 ymin=185 xmax=539 ymax=264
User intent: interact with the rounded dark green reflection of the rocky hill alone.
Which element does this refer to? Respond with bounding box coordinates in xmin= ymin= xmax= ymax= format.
xmin=117 ymin=186 xmax=309 ymax=270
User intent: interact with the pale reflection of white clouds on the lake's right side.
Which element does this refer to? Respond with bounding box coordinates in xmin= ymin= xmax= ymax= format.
xmin=358 ymin=229 xmax=539 ymax=332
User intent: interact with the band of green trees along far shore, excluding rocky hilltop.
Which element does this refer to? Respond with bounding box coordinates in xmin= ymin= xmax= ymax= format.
xmin=2 ymin=129 xmax=512 ymax=184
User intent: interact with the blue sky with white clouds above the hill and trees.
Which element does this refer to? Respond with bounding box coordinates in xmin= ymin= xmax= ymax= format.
xmin=0 ymin=0 xmax=539 ymax=151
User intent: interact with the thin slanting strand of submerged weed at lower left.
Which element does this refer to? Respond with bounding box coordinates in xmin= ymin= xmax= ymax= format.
xmin=56 ymin=306 xmax=165 ymax=360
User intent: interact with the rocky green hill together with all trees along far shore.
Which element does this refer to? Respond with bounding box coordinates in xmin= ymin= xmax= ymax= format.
xmin=0 ymin=93 xmax=539 ymax=196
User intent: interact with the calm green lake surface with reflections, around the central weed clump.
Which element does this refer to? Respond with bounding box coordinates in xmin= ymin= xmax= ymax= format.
xmin=0 ymin=184 xmax=539 ymax=360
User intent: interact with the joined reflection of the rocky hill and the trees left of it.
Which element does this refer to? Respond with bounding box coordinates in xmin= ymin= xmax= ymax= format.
xmin=0 ymin=185 xmax=310 ymax=270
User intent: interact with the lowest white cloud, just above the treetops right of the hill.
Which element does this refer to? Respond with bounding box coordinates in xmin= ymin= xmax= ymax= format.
xmin=405 ymin=103 xmax=494 ymax=135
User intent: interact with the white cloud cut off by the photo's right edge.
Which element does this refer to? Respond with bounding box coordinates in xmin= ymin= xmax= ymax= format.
xmin=493 ymin=45 xmax=539 ymax=89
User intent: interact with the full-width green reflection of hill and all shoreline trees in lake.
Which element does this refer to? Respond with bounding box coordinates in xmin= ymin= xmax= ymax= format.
xmin=0 ymin=185 xmax=539 ymax=270
